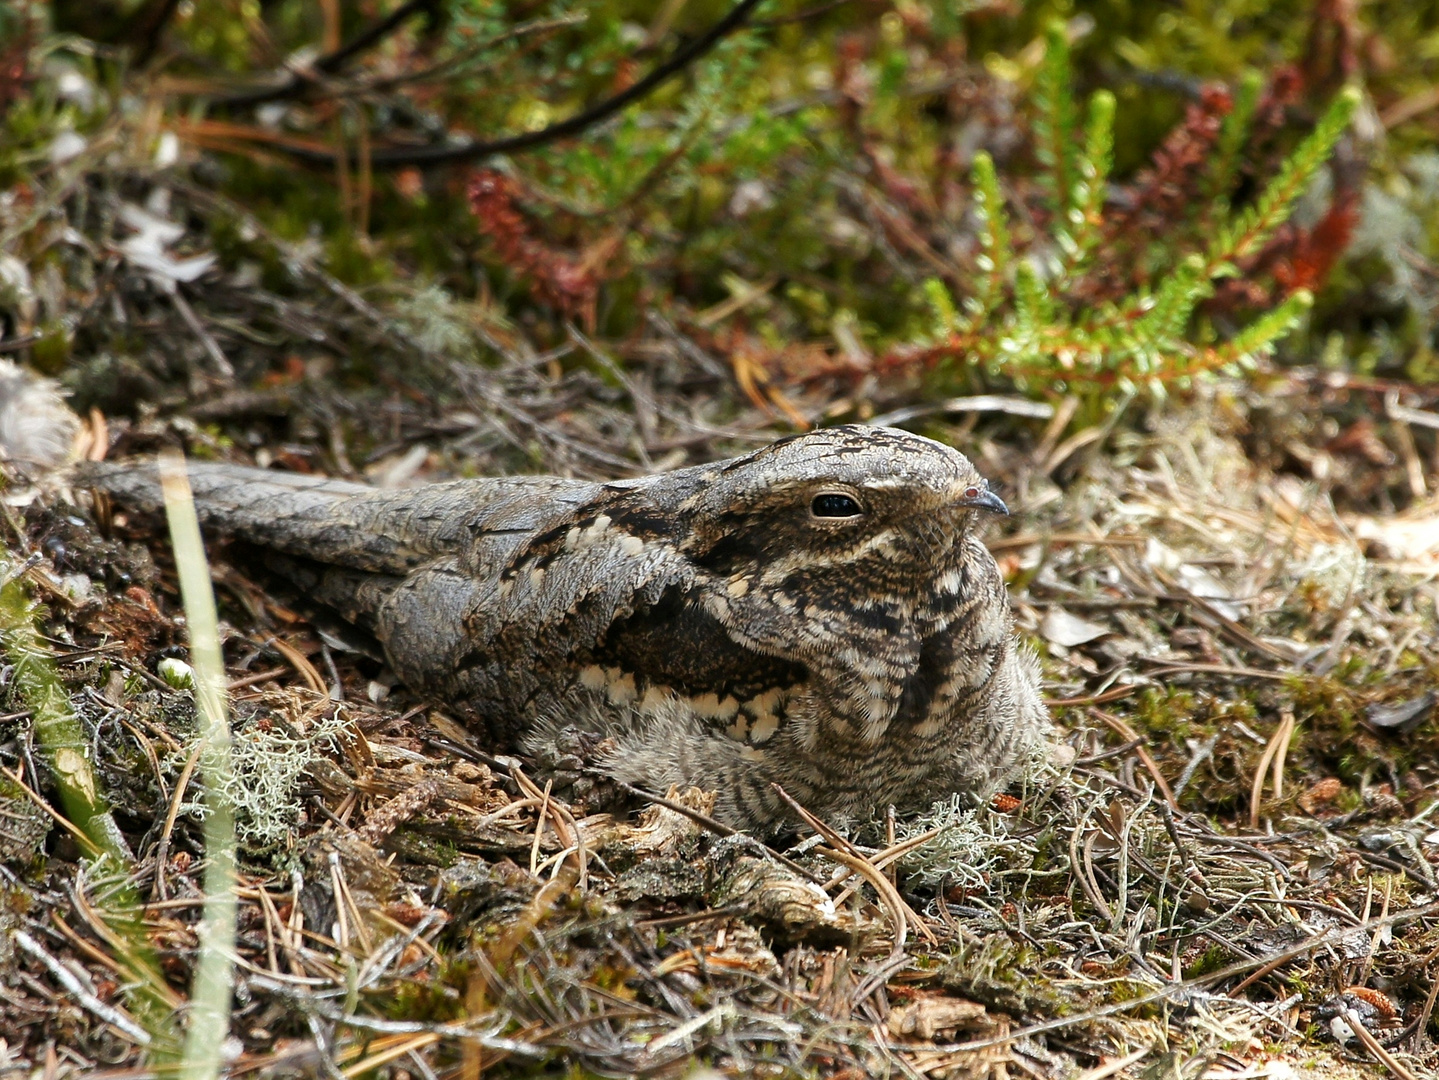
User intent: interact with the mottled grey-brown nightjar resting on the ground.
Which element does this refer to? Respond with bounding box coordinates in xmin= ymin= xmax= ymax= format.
xmin=86 ymin=427 xmax=1048 ymax=831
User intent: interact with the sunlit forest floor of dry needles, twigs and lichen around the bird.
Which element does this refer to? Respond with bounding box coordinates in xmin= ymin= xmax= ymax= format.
xmin=0 ymin=283 xmax=1439 ymax=1080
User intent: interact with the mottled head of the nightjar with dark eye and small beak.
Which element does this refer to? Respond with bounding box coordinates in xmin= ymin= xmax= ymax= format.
xmin=659 ymin=427 xmax=1007 ymax=741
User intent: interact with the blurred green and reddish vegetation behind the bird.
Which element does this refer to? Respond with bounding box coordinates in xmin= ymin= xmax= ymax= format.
xmin=0 ymin=0 xmax=1439 ymax=506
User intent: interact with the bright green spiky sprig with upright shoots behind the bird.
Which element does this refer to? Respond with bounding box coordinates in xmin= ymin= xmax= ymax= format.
xmin=924 ymin=26 xmax=1358 ymax=397
